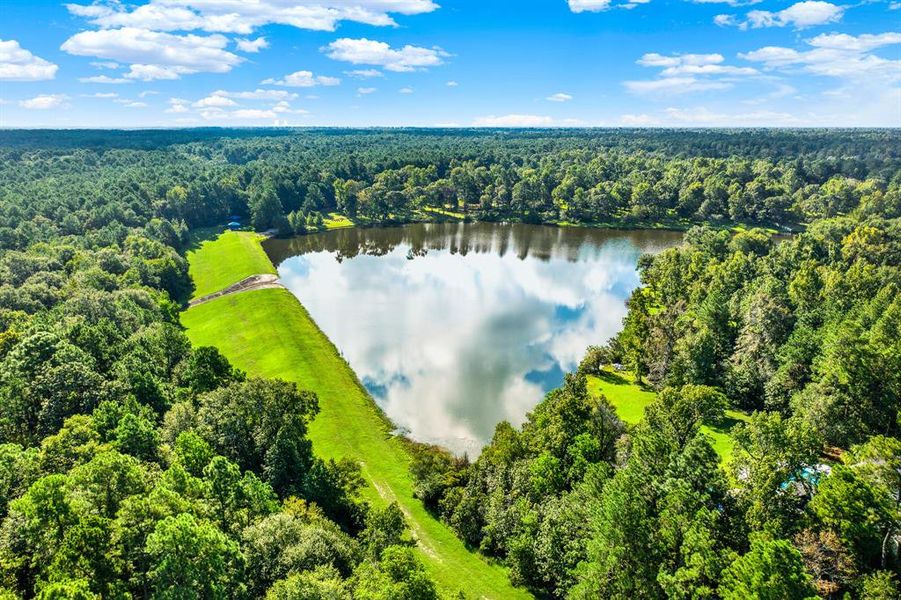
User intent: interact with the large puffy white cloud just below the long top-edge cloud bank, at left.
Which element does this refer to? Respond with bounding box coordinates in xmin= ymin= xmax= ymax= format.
xmin=62 ymin=27 xmax=243 ymax=81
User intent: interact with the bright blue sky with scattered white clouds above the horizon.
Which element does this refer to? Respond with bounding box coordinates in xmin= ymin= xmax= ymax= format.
xmin=0 ymin=0 xmax=901 ymax=127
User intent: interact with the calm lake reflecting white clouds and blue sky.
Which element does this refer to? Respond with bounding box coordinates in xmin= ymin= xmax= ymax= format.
xmin=265 ymin=223 xmax=682 ymax=456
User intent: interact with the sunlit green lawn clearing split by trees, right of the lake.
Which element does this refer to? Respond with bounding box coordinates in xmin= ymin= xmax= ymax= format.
xmin=588 ymin=372 xmax=749 ymax=461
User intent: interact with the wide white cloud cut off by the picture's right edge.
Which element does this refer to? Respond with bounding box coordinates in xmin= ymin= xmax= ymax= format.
xmin=739 ymin=32 xmax=901 ymax=84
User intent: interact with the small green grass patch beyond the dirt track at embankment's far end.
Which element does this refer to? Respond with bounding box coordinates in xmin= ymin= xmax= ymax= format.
xmin=188 ymin=231 xmax=275 ymax=298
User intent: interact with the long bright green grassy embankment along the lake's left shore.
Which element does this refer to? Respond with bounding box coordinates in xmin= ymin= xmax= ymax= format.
xmin=182 ymin=233 xmax=530 ymax=598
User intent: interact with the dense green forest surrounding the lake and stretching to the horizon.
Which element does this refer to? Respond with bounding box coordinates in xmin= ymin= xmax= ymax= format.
xmin=0 ymin=130 xmax=901 ymax=600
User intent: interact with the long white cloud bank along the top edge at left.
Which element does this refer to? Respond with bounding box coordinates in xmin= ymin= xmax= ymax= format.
xmin=66 ymin=0 xmax=438 ymax=35
